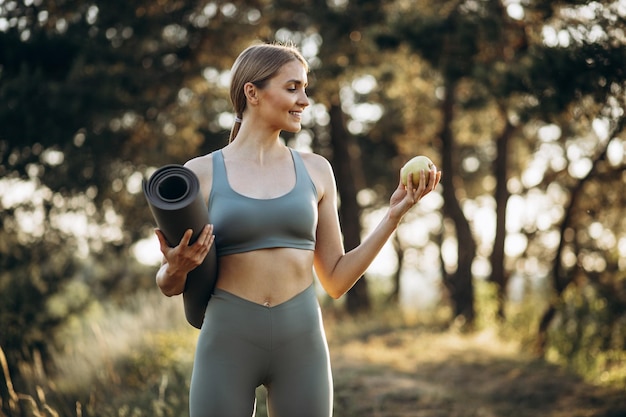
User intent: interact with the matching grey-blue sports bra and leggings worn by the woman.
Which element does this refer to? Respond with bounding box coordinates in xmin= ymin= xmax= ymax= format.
xmin=189 ymin=149 xmax=333 ymax=417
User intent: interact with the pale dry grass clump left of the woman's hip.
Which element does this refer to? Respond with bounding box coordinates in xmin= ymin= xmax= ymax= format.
xmin=48 ymin=291 xmax=197 ymax=391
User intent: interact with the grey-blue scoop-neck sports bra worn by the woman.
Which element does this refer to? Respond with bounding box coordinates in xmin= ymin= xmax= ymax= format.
xmin=208 ymin=149 xmax=318 ymax=256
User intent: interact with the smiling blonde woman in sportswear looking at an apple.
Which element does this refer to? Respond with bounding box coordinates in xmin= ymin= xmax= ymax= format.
xmin=156 ymin=44 xmax=441 ymax=417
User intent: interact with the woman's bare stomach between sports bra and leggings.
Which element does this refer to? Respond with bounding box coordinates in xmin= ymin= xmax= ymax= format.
xmin=215 ymin=248 xmax=313 ymax=307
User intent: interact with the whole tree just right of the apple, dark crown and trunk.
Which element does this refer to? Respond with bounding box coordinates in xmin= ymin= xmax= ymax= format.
xmin=378 ymin=2 xmax=492 ymax=326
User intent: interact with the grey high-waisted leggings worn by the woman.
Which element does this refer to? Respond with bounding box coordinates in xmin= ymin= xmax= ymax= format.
xmin=189 ymin=285 xmax=333 ymax=417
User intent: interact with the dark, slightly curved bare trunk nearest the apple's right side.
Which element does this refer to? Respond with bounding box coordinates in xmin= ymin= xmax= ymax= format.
xmin=440 ymin=79 xmax=476 ymax=327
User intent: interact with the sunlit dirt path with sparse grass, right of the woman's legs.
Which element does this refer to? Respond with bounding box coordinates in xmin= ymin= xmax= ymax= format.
xmin=329 ymin=328 xmax=626 ymax=417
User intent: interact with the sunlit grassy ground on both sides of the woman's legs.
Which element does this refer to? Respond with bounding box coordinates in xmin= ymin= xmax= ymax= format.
xmin=0 ymin=291 xmax=626 ymax=417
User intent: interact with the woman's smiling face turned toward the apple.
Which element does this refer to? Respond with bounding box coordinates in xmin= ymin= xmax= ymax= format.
xmin=252 ymin=61 xmax=309 ymax=132
